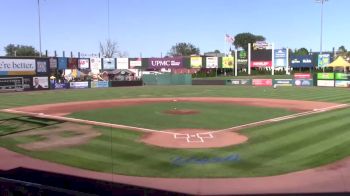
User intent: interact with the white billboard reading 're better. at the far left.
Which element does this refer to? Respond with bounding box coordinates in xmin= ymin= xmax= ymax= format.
xmin=0 ymin=58 xmax=36 ymax=75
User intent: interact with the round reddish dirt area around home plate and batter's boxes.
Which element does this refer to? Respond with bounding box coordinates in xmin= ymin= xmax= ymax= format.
xmin=142 ymin=129 xmax=248 ymax=148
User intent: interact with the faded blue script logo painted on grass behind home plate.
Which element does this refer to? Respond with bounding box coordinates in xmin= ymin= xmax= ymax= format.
xmin=171 ymin=154 xmax=240 ymax=166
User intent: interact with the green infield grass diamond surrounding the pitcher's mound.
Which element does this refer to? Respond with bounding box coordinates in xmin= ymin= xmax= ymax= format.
xmin=69 ymin=102 xmax=295 ymax=130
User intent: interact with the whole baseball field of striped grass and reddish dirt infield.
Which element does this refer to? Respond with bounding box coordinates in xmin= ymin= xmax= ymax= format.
xmin=0 ymin=86 xmax=350 ymax=193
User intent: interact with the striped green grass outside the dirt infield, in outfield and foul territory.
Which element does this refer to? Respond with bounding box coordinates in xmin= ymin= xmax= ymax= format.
xmin=0 ymin=86 xmax=350 ymax=177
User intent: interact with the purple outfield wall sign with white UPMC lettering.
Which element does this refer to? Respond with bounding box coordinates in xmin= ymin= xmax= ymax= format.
xmin=148 ymin=57 xmax=183 ymax=68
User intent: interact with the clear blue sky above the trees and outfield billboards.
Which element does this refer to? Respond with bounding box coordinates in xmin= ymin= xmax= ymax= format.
xmin=0 ymin=0 xmax=350 ymax=57
